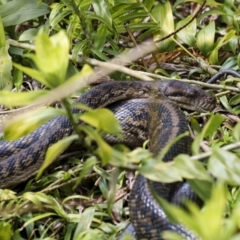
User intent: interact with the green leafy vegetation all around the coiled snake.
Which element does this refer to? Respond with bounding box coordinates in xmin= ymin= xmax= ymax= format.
xmin=0 ymin=0 xmax=240 ymax=240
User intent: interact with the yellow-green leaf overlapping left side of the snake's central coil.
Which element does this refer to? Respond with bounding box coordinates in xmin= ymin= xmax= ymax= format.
xmin=80 ymin=108 xmax=121 ymax=134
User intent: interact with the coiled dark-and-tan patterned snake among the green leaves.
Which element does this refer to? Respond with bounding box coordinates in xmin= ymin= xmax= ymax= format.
xmin=0 ymin=80 xmax=216 ymax=240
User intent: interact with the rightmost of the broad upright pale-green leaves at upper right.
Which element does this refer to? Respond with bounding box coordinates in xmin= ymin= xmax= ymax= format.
xmin=197 ymin=21 xmax=215 ymax=56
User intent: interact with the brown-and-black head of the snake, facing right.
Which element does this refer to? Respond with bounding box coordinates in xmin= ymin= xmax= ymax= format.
xmin=160 ymin=80 xmax=216 ymax=112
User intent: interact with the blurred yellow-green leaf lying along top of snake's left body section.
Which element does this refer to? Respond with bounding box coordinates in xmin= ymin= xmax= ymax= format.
xmin=4 ymin=108 xmax=64 ymax=140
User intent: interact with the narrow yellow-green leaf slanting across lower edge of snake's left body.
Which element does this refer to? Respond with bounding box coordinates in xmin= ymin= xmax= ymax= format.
xmin=36 ymin=135 xmax=78 ymax=179
